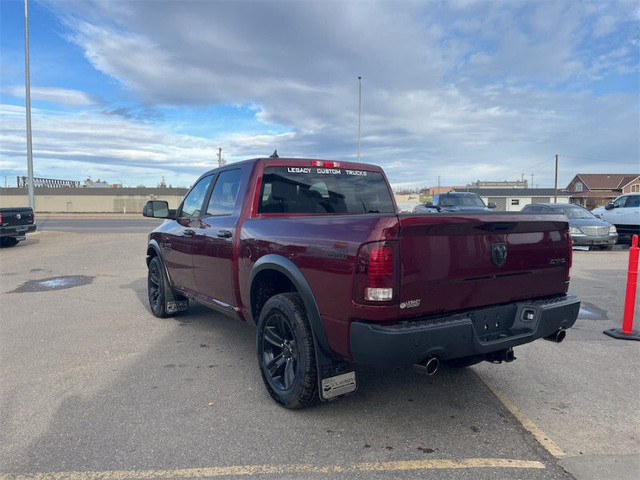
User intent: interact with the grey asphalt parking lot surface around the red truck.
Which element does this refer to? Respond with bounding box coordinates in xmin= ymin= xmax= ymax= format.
xmin=0 ymin=231 xmax=640 ymax=480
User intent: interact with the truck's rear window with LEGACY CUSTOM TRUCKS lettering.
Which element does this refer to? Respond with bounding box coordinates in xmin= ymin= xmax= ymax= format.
xmin=258 ymin=166 xmax=394 ymax=214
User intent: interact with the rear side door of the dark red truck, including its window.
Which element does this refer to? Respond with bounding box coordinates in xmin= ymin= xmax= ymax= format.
xmin=192 ymin=168 xmax=243 ymax=307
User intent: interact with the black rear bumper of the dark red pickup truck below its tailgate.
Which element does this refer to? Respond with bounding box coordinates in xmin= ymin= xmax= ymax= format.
xmin=350 ymin=295 xmax=580 ymax=366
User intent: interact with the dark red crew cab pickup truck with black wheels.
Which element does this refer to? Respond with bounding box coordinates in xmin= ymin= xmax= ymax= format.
xmin=144 ymin=158 xmax=580 ymax=408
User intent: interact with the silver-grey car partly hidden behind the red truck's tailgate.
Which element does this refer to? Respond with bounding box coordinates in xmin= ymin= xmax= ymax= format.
xmin=522 ymin=203 xmax=618 ymax=250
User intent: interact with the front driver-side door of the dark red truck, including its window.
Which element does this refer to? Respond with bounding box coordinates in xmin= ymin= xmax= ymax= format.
xmin=161 ymin=175 xmax=213 ymax=291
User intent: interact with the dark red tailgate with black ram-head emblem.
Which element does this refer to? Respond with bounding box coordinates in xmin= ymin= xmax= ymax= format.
xmin=399 ymin=213 xmax=571 ymax=318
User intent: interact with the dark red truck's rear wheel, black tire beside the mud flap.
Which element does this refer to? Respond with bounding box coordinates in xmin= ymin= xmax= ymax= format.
xmin=256 ymin=293 xmax=318 ymax=409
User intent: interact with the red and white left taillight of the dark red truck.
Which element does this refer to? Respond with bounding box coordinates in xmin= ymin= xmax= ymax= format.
xmin=354 ymin=242 xmax=397 ymax=302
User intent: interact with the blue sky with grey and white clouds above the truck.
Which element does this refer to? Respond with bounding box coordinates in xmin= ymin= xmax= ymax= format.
xmin=0 ymin=0 xmax=640 ymax=188
